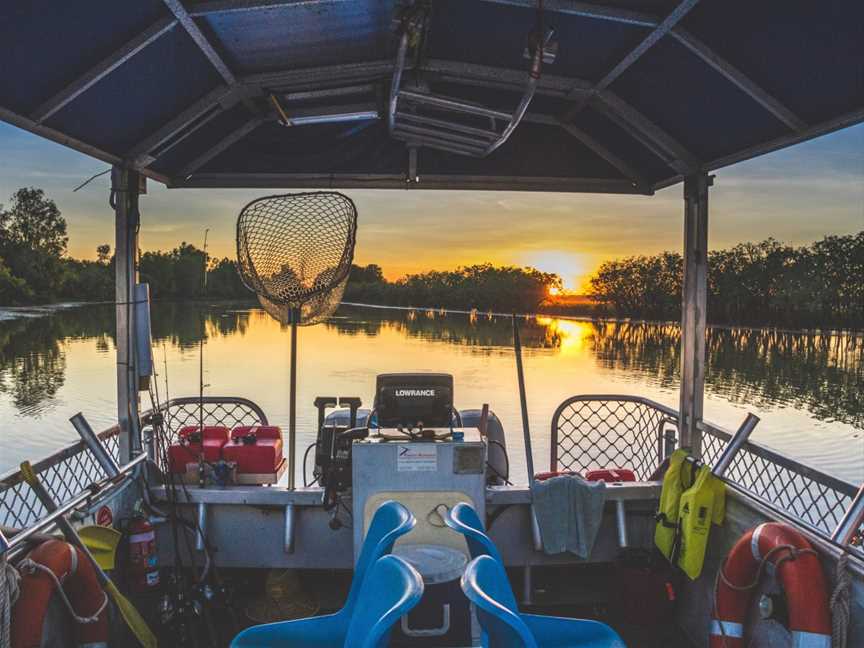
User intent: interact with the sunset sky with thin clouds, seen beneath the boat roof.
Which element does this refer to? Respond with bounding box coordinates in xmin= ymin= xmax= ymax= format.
xmin=0 ymin=124 xmax=864 ymax=294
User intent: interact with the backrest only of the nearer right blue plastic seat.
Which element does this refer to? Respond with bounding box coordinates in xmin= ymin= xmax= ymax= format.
xmin=462 ymin=556 xmax=537 ymax=648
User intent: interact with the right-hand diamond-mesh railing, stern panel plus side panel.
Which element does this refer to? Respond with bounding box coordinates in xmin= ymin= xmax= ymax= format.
xmin=550 ymin=395 xmax=864 ymax=544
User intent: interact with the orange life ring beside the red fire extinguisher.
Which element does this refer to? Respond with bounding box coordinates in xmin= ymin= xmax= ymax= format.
xmin=12 ymin=540 xmax=109 ymax=648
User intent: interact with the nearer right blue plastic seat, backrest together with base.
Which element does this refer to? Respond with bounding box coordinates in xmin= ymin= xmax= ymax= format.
xmin=462 ymin=556 xmax=626 ymax=648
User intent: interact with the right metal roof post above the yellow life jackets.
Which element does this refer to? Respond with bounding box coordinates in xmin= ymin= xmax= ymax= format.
xmin=678 ymin=172 xmax=713 ymax=457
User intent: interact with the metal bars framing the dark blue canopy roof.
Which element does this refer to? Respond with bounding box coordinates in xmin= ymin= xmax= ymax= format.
xmin=0 ymin=0 xmax=864 ymax=194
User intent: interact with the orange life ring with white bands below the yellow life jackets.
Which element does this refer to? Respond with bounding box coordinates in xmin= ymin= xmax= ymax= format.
xmin=710 ymin=522 xmax=831 ymax=648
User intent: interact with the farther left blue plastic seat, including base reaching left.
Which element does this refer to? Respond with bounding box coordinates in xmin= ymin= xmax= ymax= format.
xmin=231 ymin=500 xmax=417 ymax=648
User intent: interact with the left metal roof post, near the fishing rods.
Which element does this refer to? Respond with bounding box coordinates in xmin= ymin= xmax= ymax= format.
xmin=111 ymin=165 xmax=141 ymax=466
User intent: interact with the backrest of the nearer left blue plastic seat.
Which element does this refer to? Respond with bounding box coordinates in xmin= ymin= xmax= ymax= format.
xmin=344 ymin=555 xmax=423 ymax=648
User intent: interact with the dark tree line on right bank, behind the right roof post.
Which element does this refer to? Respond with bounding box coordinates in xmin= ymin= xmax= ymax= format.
xmin=590 ymin=231 xmax=864 ymax=328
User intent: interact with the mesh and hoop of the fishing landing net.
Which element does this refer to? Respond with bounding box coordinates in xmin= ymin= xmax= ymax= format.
xmin=237 ymin=191 xmax=357 ymax=325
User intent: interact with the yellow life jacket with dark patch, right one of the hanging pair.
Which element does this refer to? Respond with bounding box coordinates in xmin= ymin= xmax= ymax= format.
xmin=674 ymin=466 xmax=726 ymax=580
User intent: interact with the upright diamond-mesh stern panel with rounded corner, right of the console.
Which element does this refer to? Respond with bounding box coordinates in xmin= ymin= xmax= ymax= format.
xmin=550 ymin=396 xmax=677 ymax=480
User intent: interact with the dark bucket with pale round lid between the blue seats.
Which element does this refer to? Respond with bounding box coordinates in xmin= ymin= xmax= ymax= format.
xmin=391 ymin=544 xmax=471 ymax=646
